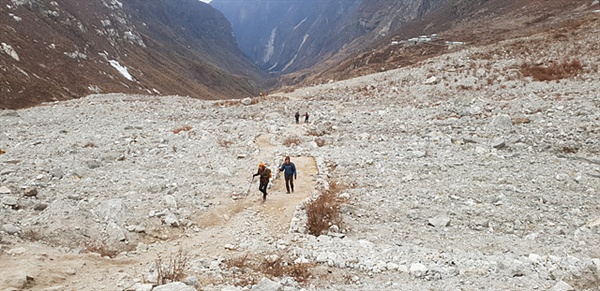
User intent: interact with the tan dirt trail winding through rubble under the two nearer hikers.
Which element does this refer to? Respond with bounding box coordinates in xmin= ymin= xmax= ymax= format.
xmin=0 ymin=125 xmax=317 ymax=290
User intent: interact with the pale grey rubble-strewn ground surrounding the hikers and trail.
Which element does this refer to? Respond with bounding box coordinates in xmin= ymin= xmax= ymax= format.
xmin=0 ymin=4 xmax=600 ymax=291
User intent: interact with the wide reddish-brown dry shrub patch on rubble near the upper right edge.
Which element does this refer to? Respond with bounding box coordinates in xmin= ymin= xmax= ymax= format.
xmin=521 ymin=60 xmax=583 ymax=81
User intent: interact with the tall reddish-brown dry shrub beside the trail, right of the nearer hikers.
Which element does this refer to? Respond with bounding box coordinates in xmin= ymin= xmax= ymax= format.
xmin=306 ymin=183 xmax=346 ymax=236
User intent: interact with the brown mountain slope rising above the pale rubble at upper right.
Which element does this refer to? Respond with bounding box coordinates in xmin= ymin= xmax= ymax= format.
xmin=280 ymin=0 xmax=600 ymax=85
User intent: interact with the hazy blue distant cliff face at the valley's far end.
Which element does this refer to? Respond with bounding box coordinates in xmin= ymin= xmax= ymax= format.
xmin=211 ymin=0 xmax=443 ymax=74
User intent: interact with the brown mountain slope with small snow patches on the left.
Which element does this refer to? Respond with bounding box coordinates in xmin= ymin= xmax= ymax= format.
xmin=0 ymin=0 xmax=262 ymax=108
